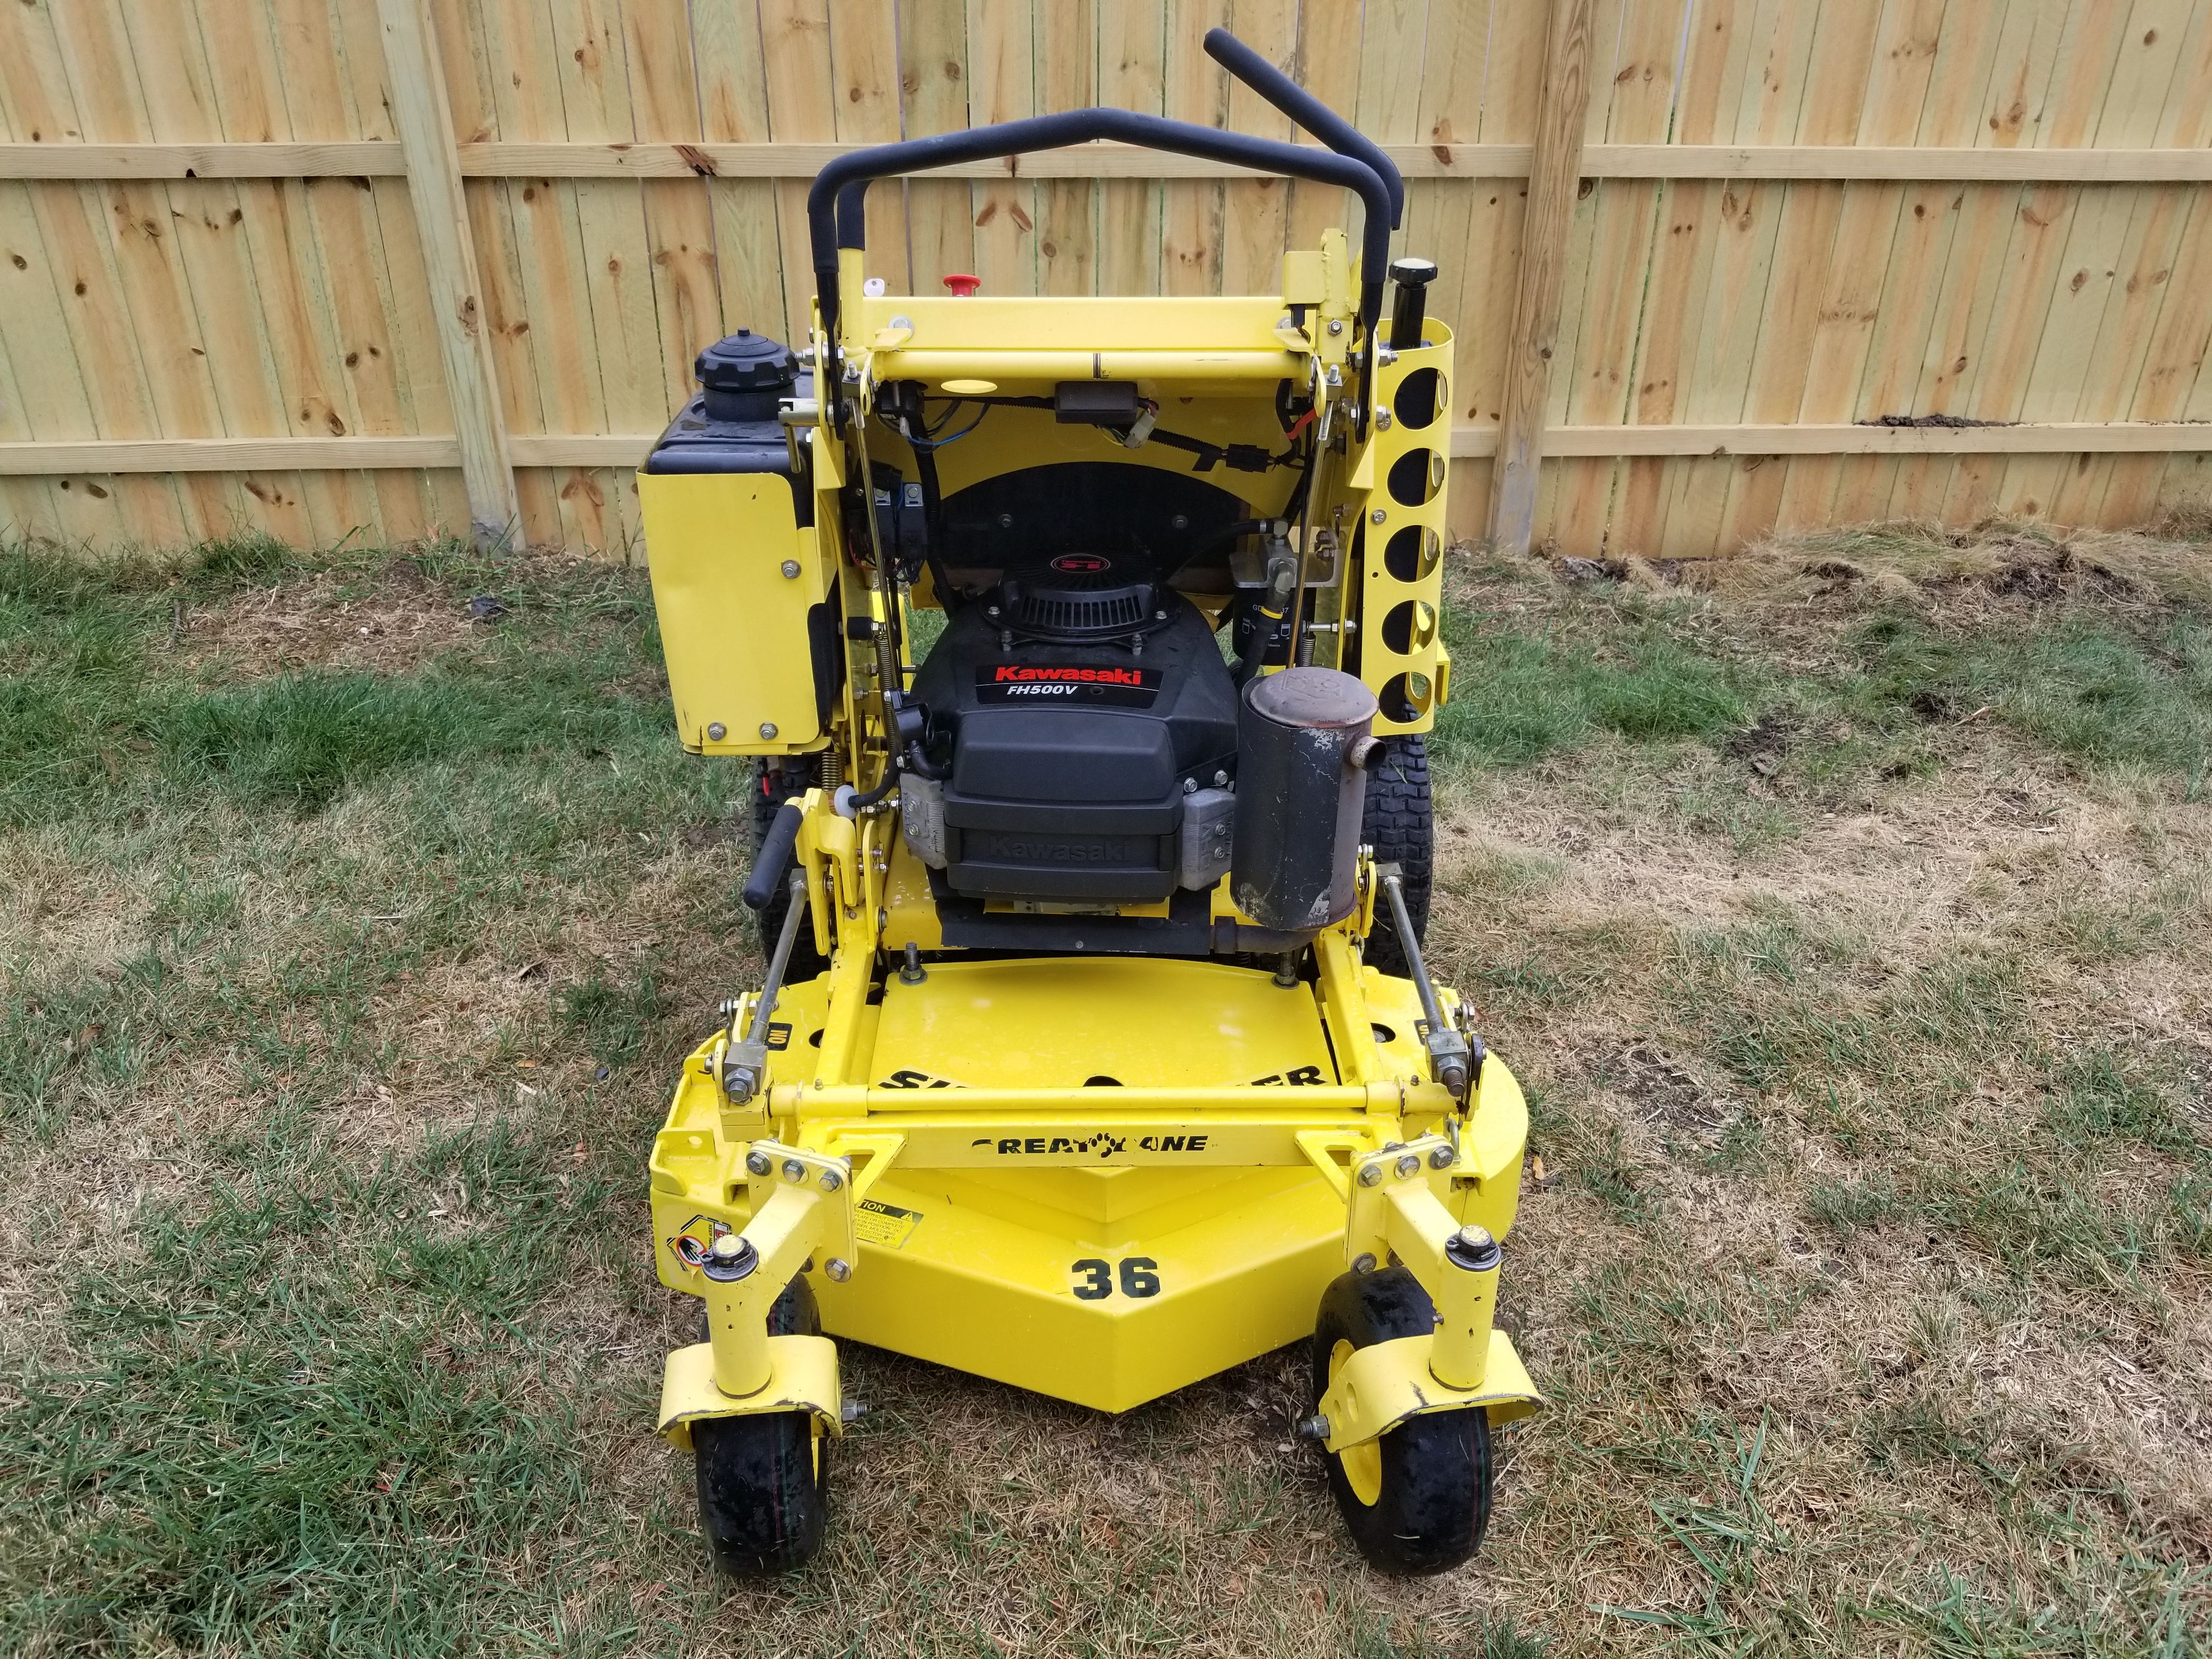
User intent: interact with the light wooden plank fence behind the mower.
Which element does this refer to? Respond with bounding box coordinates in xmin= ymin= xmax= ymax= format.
xmin=0 ymin=0 xmax=2212 ymax=557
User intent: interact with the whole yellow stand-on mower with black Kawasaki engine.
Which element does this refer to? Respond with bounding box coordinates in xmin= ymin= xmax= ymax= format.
xmin=637 ymin=31 xmax=1537 ymax=1573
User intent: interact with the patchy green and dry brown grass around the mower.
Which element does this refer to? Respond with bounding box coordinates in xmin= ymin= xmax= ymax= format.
xmin=0 ymin=527 xmax=2212 ymax=1659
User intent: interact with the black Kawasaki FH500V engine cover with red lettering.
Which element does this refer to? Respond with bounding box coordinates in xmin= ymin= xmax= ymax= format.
xmin=907 ymin=571 xmax=1237 ymax=905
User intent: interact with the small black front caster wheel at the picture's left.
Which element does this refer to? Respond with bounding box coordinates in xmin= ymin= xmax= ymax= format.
xmin=692 ymin=1278 xmax=830 ymax=1577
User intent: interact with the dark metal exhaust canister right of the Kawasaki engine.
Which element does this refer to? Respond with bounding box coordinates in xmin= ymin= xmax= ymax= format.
xmin=1230 ymin=668 xmax=1376 ymax=934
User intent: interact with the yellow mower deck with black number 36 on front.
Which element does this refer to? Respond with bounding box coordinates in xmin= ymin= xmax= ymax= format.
xmin=652 ymin=958 xmax=1526 ymax=1411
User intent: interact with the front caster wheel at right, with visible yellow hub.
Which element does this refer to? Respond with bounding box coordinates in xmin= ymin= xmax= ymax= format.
xmin=1312 ymin=1267 xmax=1491 ymax=1575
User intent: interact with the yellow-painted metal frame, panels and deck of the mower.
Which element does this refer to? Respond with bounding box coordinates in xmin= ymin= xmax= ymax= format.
xmin=639 ymin=230 xmax=1537 ymax=1451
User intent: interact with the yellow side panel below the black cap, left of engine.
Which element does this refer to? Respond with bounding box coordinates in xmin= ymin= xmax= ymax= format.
xmin=637 ymin=473 xmax=843 ymax=754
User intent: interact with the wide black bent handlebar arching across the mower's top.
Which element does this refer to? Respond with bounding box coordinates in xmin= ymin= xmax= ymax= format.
xmin=808 ymin=109 xmax=1393 ymax=347
